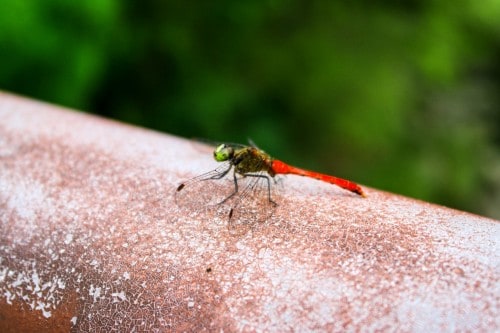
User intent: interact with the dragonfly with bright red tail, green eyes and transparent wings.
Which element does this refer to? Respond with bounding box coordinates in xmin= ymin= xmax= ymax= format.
xmin=175 ymin=143 xmax=366 ymax=227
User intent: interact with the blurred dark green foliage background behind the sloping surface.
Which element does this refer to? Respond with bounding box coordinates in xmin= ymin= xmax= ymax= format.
xmin=0 ymin=0 xmax=500 ymax=219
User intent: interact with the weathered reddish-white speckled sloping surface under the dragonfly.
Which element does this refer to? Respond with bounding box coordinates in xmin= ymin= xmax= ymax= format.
xmin=0 ymin=93 xmax=500 ymax=332
